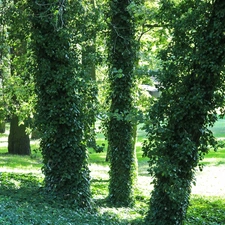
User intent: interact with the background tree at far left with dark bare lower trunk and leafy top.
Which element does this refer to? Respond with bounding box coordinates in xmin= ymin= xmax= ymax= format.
xmin=5 ymin=0 xmax=32 ymax=155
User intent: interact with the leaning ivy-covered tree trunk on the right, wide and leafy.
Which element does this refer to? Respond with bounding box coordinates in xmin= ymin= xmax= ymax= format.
xmin=144 ymin=0 xmax=225 ymax=225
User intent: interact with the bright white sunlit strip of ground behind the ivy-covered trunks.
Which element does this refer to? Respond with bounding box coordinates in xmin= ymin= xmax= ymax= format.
xmin=0 ymin=133 xmax=225 ymax=197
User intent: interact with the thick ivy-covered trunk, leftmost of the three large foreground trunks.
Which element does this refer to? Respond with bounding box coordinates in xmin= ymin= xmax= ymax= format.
xmin=29 ymin=0 xmax=90 ymax=207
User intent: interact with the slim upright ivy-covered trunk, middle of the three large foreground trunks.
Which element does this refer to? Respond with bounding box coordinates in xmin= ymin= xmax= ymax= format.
xmin=107 ymin=0 xmax=136 ymax=206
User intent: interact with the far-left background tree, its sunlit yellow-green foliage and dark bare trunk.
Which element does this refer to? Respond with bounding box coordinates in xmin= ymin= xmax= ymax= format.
xmin=1 ymin=0 xmax=35 ymax=155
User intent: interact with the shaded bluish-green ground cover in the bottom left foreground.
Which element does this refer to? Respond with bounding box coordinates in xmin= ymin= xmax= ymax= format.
xmin=0 ymin=173 xmax=133 ymax=225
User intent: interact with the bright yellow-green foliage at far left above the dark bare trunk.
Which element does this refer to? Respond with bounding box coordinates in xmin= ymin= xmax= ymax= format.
xmin=1 ymin=0 xmax=36 ymax=123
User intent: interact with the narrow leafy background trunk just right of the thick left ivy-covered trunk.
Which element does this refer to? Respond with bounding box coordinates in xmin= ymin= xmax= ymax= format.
xmin=79 ymin=0 xmax=101 ymax=151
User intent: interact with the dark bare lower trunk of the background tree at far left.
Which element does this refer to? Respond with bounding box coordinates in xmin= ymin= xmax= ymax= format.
xmin=8 ymin=116 xmax=31 ymax=155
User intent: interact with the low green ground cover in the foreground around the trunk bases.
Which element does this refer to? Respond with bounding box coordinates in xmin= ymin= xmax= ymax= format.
xmin=0 ymin=172 xmax=225 ymax=225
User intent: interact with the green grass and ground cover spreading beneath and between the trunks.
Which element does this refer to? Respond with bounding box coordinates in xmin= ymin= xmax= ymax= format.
xmin=0 ymin=120 xmax=225 ymax=225
